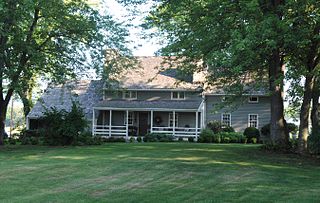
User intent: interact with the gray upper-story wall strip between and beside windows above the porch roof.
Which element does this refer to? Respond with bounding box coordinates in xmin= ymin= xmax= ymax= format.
xmin=105 ymin=90 xmax=201 ymax=101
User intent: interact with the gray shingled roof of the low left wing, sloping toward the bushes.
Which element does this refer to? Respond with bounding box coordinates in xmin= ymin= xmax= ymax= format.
xmin=28 ymin=80 xmax=103 ymax=118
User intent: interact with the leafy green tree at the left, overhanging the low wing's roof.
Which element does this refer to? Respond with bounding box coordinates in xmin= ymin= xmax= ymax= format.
xmin=0 ymin=0 xmax=129 ymax=144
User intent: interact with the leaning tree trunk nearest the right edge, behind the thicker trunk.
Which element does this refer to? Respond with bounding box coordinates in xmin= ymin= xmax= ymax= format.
xmin=298 ymin=75 xmax=314 ymax=153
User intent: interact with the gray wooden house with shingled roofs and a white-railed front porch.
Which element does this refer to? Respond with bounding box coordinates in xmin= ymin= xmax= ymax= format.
xmin=27 ymin=57 xmax=270 ymax=137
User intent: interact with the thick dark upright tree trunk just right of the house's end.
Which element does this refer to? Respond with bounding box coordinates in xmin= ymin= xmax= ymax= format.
xmin=269 ymin=50 xmax=289 ymax=148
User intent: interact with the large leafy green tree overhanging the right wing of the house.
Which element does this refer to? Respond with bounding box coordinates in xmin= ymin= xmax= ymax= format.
xmin=141 ymin=0 xmax=288 ymax=146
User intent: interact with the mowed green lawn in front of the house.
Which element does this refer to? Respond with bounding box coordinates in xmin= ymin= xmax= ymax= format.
xmin=0 ymin=143 xmax=320 ymax=202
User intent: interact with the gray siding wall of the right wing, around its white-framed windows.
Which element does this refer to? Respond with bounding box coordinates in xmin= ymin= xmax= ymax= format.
xmin=206 ymin=95 xmax=271 ymax=132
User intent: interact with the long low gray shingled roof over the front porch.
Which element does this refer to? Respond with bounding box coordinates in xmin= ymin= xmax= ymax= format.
xmin=94 ymin=100 xmax=201 ymax=111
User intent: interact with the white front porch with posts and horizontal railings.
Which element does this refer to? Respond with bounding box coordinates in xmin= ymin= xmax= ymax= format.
xmin=92 ymin=107 xmax=203 ymax=139
